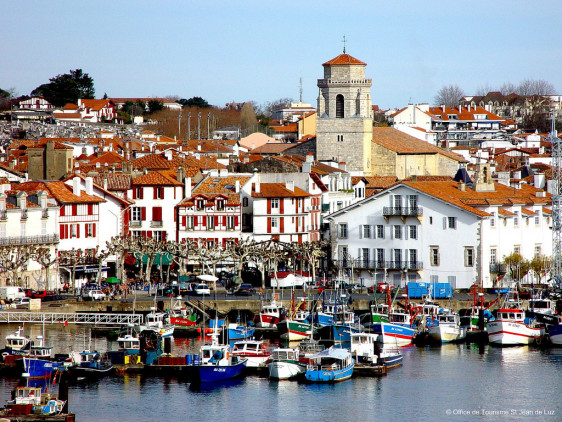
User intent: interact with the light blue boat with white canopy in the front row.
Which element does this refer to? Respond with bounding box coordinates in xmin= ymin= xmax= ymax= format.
xmin=304 ymin=346 xmax=355 ymax=383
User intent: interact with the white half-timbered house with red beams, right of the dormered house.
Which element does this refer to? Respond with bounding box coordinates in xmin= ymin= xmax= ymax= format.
xmin=251 ymin=174 xmax=313 ymax=243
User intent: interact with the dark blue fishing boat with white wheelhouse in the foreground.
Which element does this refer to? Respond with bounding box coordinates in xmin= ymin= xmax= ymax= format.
xmin=193 ymin=333 xmax=248 ymax=383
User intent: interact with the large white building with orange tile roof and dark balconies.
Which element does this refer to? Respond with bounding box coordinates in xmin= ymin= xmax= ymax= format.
xmin=326 ymin=165 xmax=552 ymax=289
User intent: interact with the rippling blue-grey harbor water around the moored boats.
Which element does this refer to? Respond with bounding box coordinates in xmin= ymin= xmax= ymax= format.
xmin=0 ymin=324 xmax=562 ymax=422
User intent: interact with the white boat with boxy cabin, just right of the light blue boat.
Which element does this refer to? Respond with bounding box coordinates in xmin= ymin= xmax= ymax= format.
xmin=350 ymin=333 xmax=404 ymax=369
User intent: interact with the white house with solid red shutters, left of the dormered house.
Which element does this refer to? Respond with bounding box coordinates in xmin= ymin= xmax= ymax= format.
xmin=125 ymin=171 xmax=183 ymax=241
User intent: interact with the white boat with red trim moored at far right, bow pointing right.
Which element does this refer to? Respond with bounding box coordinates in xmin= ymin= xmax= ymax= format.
xmin=487 ymin=308 xmax=544 ymax=346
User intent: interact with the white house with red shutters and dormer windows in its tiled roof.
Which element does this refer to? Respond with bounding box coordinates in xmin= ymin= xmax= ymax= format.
xmin=177 ymin=172 xmax=255 ymax=246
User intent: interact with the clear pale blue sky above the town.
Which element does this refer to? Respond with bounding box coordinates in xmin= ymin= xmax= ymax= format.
xmin=0 ymin=0 xmax=562 ymax=109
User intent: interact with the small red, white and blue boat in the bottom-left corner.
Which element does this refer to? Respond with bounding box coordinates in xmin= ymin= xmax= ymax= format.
xmin=2 ymin=387 xmax=66 ymax=420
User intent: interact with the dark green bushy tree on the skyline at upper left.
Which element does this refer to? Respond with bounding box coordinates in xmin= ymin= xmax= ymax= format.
xmin=31 ymin=69 xmax=96 ymax=107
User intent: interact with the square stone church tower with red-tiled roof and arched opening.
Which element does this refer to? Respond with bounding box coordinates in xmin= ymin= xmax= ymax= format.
xmin=316 ymin=50 xmax=373 ymax=176
